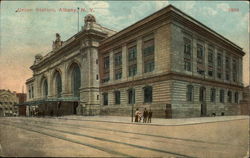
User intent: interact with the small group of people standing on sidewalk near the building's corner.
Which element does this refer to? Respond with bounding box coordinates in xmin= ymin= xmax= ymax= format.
xmin=135 ymin=108 xmax=153 ymax=123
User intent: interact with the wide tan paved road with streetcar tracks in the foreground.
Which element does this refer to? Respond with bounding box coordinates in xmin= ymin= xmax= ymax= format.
xmin=0 ymin=117 xmax=249 ymax=158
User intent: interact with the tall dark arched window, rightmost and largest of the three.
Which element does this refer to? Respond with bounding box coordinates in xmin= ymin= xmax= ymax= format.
xmin=71 ymin=64 xmax=81 ymax=97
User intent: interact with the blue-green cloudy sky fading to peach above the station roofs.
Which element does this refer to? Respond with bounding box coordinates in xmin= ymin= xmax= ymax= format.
xmin=0 ymin=1 xmax=250 ymax=92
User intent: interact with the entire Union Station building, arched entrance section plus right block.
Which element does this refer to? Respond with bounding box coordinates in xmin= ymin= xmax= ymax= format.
xmin=26 ymin=5 xmax=245 ymax=118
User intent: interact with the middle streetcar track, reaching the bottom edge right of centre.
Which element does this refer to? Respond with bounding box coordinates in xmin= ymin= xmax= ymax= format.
xmin=4 ymin=119 xmax=193 ymax=158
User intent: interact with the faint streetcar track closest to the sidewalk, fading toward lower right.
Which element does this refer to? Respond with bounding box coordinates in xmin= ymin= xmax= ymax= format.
xmin=16 ymin=117 xmax=243 ymax=147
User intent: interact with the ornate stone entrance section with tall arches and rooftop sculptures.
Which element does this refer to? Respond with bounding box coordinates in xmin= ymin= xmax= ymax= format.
xmin=26 ymin=15 xmax=115 ymax=114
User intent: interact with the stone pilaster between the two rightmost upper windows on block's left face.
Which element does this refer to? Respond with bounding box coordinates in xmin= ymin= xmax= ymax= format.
xmin=136 ymin=38 xmax=144 ymax=75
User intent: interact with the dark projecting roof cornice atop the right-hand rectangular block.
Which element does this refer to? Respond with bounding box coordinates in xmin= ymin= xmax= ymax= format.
xmin=100 ymin=5 xmax=245 ymax=56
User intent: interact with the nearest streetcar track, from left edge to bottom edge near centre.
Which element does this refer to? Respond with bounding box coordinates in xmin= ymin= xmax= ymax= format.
xmin=0 ymin=122 xmax=133 ymax=157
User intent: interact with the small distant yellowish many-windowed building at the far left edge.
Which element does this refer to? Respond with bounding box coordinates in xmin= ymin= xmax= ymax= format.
xmin=0 ymin=89 xmax=19 ymax=116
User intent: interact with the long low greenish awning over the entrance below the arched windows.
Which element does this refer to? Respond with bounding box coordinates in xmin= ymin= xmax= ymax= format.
xmin=15 ymin=97 xmax=80 ymax=106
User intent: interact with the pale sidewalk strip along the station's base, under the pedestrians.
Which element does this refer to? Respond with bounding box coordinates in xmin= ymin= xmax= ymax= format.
xmin=58 ymin=115 xmax=249 ymax=126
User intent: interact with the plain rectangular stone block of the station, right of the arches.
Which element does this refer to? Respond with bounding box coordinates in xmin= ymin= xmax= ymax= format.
xmin=99 ymin=5 xmax=245 ymax=118
